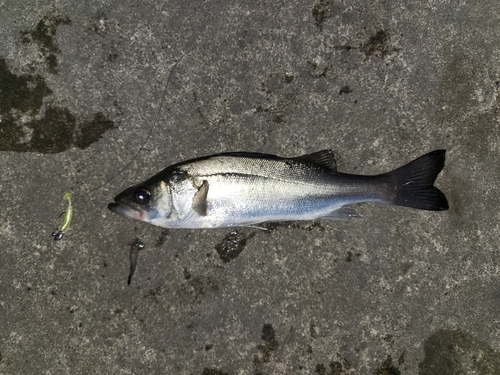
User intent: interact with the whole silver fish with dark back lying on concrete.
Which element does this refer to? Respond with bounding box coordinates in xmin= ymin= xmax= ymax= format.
xmin=108 ymin=150 xmax=449 ymax=229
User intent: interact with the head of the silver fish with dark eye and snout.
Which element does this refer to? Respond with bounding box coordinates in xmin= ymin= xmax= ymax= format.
xmin=108 ymin=181 xmax=174 ymax=227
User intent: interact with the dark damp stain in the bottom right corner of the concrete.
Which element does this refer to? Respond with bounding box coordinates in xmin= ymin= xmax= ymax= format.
xmin=418 ymin=329 xmax=500 ymax=375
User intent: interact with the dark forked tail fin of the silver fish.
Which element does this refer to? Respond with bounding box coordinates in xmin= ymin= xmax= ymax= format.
xmin=388 ymin=150 xmax=448 ymax=211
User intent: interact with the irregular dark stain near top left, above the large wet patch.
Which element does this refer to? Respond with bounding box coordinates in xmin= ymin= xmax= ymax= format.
xmin=21 ymin=16 xmax=71 ymax=74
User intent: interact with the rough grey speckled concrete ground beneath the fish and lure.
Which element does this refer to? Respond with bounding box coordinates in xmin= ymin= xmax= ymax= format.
xmin=0 ymin=0 xmax=500 ymax=375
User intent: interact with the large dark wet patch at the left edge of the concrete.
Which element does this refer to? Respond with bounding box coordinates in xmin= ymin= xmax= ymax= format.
xmin=0 ymin=58 xmax=116 ymax=153
